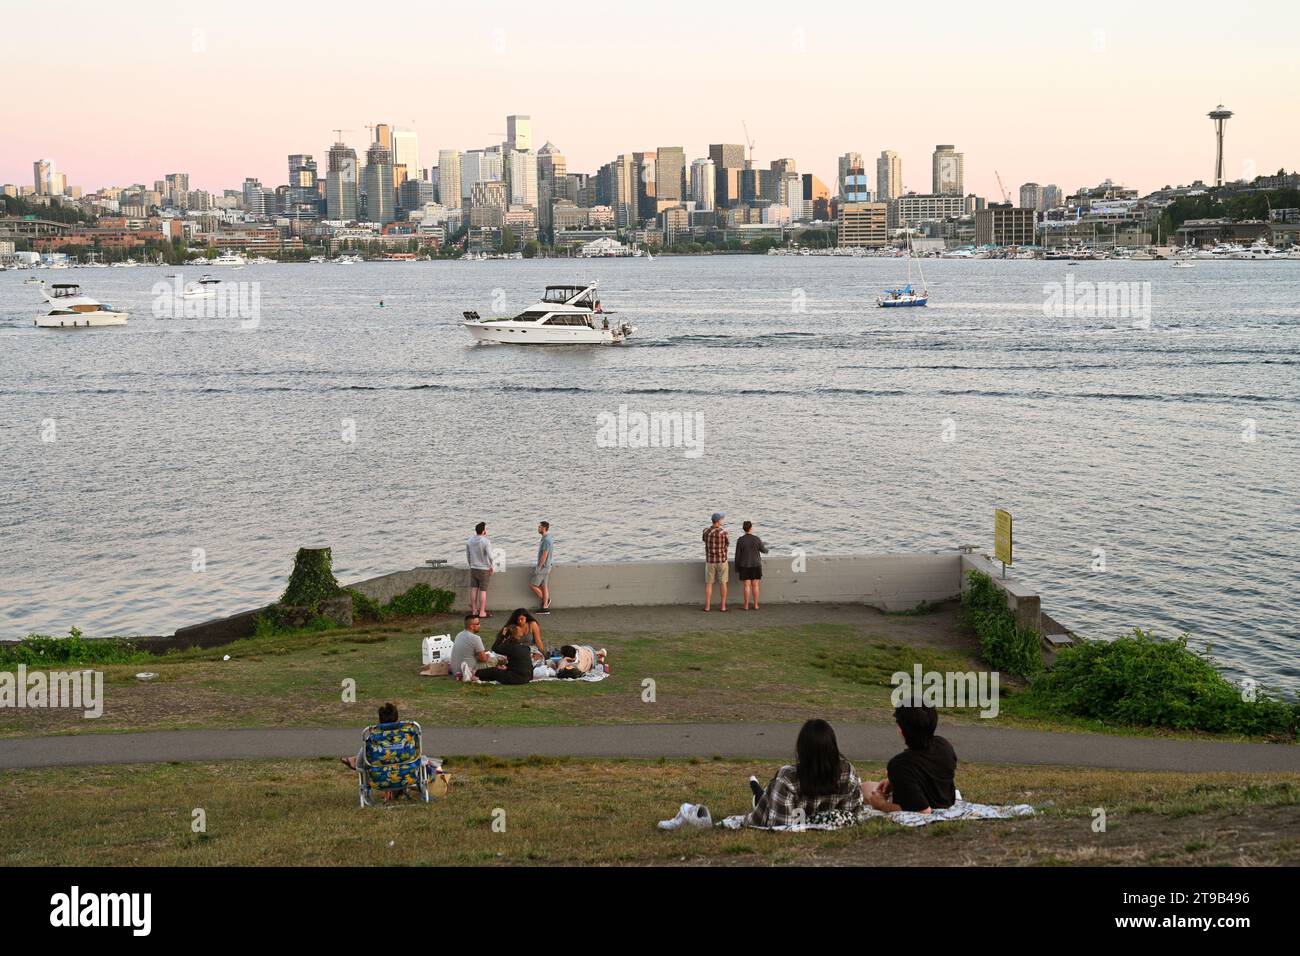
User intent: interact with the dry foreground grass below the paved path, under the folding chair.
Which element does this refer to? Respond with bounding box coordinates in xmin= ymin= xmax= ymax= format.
xmin=0 ymin=757 xmax=1300 ymax=866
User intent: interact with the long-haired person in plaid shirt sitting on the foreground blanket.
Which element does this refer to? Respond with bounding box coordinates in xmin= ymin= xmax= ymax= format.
xmin=745 ymin=719 xmax=862 ymax=827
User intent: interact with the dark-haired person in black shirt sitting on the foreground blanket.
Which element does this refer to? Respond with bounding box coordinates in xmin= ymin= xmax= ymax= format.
xmin=862 ymin=706 xmax=957 ymax=813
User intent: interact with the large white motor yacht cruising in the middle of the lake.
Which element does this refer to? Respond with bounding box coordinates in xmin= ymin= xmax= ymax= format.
xmin=464 ymin=282 xmax=636 ymax=345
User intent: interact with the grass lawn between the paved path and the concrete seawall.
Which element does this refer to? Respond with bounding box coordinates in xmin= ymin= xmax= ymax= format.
xmin=0 ymin=604 xmax=1289 ymax=736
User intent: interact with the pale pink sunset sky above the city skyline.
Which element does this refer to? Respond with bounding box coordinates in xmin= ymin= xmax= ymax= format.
xmin=0 ymin=0 xmax=1300 ymax=198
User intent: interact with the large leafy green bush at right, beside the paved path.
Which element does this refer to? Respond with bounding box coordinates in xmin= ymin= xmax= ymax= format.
xmin=1027 ymin=630 xmax=1300 ymax=737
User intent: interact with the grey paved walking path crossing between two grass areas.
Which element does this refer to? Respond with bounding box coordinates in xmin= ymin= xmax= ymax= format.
xmin=0 ymin=723 xmax=1300 ymax=773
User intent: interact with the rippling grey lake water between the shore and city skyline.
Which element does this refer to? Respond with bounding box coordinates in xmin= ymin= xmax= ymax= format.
xmin=0 ymin=256 xmax=1300 ymax=689
